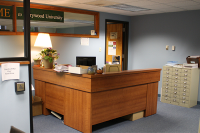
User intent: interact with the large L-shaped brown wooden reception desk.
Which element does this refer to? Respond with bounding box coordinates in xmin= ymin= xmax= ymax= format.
xmin=33 ymin=67 xmax=161 ymax=133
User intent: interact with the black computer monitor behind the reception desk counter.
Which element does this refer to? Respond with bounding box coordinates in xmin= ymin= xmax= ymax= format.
xmin=76 ymin=56 xmax=96 ymax=66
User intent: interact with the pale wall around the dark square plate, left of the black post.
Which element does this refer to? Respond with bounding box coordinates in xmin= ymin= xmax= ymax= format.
xmin=0 ymin=65 xmax=30 ymax=133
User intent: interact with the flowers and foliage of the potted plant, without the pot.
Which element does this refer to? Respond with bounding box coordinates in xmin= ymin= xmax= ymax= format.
xmin=40 ymin=48 xmax=60 ymax=63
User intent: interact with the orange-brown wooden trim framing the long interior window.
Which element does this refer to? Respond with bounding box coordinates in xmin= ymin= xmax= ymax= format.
xmin=0 ymin=0 xmax=99 ymax=38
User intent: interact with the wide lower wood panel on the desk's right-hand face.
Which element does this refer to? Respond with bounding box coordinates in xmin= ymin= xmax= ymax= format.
xmin=92 ymin=85 xmax=147 ymax=125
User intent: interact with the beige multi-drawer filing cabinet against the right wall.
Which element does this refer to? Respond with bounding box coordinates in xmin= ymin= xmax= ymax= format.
xmin=161 ymin=66 xmax=199 ymax=108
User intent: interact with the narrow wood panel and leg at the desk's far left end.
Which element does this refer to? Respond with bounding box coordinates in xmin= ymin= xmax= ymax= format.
xmin=35 ymin=80 xmax=50 ymax=115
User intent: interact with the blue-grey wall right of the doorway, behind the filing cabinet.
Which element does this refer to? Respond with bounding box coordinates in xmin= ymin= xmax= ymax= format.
xmin=129 ymin=11 xmax=200 ymax=101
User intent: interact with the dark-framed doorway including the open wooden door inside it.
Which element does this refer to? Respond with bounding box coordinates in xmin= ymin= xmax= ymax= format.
xmin=105 ymin=19 xmax=129 ymax=70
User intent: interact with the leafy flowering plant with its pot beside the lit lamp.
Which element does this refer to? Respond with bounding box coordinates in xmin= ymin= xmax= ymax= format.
xmin=40 ymin=48 xmax=59 ymax=69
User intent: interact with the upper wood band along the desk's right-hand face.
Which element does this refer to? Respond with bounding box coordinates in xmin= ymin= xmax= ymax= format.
xmin=91 ymin=71 xmax=160 ymax=92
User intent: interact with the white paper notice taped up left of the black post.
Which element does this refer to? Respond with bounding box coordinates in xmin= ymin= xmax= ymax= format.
xmin=1 ymin=63 xmax=20 ymax=81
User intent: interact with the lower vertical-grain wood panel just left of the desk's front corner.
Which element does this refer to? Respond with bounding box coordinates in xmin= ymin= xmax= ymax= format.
xmin=64 ymin=88 xmax=92 ymax=133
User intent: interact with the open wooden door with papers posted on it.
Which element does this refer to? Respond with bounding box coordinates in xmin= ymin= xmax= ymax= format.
xmin=106 ymin=23 xmax=123 ymax=70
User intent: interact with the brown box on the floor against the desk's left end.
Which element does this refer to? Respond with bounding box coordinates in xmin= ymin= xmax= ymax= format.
xmin=32 ymin=96 xmax=42 ymax=116
